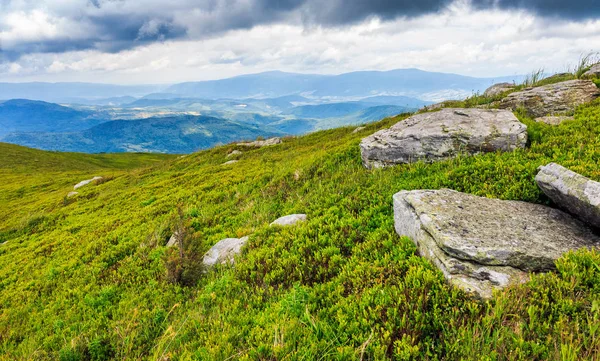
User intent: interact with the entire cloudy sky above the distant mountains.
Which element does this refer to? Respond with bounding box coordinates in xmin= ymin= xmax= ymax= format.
xmin=0 ymin=0 xmax=600 ymax=84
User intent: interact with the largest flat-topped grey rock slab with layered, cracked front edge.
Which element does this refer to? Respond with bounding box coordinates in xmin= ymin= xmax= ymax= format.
xmin=394 ymin=189 xmax=600 ymax=298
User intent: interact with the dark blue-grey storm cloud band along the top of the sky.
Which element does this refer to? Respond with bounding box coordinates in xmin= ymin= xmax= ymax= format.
xmin=0 ymin=0 xmax=600 ymax=60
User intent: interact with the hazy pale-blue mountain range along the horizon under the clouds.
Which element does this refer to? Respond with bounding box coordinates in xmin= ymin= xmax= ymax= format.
xmin=0 ymin=69 xmax=523 ymax=105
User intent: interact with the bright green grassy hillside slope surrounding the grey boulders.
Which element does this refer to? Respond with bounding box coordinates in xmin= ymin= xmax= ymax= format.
xmin=0 ymin=105 xmax=600 ymax=360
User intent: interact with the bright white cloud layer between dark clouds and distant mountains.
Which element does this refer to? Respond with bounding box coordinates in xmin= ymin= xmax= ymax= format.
xmin=0 ymin=0 xmax=600 ymax=83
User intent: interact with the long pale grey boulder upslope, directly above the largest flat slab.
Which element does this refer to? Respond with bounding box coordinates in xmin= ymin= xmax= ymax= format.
xmin=360 ymin=108 xmax=527 ymax=168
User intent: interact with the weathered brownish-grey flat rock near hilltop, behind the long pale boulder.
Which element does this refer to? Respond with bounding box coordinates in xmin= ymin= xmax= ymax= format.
xmin=498 ymin=80 xmax=600 ymax=118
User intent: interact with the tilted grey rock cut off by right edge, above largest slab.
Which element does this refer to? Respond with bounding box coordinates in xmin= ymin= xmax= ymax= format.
xmin=535 ymin=163 xmax=600 ymax=228
